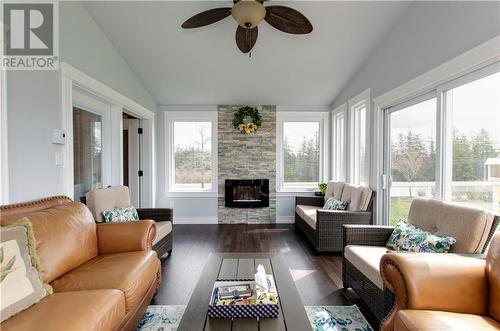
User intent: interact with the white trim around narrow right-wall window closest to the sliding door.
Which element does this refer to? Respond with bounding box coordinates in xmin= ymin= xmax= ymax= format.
xmin=346 ymin=89 xmax=371 ymax=186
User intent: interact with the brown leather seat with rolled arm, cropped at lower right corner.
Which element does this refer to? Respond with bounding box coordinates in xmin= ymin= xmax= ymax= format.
xmin=380 ymin=233 xmax=500 ymax=331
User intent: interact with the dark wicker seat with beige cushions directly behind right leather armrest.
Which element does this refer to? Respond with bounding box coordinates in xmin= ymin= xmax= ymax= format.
xmin=342 ymin=198 xmax=500 ymax=321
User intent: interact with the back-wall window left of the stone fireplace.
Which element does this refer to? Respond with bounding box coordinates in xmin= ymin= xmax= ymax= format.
xmin=166 ymin=112 xmax=217 ymax=192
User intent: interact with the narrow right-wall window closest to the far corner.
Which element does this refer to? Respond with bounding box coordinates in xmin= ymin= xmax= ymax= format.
xmin=332 ymin=104 xmax=347 ymax=181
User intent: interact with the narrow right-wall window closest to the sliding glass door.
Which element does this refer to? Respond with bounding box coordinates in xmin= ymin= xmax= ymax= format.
xmin=349 ymin=90 xmax=370 ymax=186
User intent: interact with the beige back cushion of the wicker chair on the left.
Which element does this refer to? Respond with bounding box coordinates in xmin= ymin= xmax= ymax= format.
xmin=85 ymin=186 xmax=130 ymax=223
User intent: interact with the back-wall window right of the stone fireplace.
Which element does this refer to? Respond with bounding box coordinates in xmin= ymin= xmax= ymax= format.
xmin=278 ymin=112 xmax=328 ymax=191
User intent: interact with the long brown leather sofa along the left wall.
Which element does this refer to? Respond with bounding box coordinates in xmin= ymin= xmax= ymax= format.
xmin=0 ymin=196 xmax=161 ymax=331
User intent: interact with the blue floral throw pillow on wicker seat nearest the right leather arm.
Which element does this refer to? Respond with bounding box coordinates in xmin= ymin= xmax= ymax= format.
xmin=386 ymin=220 xmax=456 ymax=253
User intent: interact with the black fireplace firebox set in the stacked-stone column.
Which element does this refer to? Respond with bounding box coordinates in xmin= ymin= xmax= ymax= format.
xmin=225 ymin=179 xmax=269 ymax=208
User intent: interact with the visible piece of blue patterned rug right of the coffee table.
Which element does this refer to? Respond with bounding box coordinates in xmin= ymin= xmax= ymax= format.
xmin=305 ymin=305 xmax=373 ymax=331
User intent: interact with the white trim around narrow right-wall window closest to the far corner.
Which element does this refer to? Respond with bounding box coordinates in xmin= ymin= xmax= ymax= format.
xmin=330 ymin=103 xmax=348 ymax=182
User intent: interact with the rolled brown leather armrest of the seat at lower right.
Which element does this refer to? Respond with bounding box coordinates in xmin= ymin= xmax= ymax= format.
xmin=380 ymin=253 xmax=488 ymax=331
